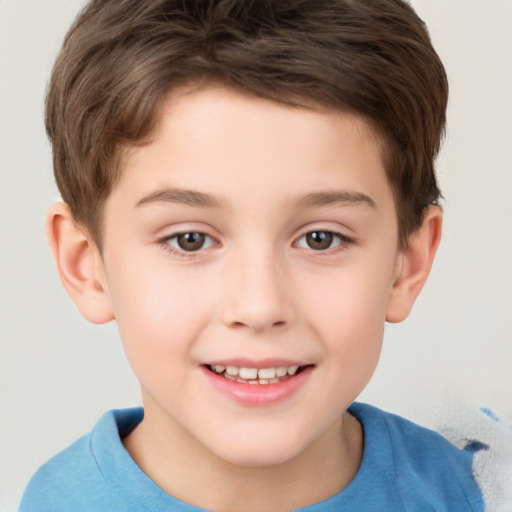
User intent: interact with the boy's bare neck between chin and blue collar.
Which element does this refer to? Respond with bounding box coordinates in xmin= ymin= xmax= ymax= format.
xmin=123 ymin=400 xmax=363 ymax=512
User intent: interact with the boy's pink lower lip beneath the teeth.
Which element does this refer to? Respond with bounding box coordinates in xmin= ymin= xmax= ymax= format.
xmin=201 ymin=366 xmax=313 ymax=407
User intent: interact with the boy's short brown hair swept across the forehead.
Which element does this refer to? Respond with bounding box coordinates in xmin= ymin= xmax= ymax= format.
xmin=46 ymin=0 xmax=448 ymax=247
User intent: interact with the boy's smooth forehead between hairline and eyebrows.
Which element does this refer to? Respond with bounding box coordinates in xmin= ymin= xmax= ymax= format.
xmin=114 ymin=87 xmax=389 ymax=214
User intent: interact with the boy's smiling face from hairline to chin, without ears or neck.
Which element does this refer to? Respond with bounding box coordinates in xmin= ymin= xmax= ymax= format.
xmin=103 ymin=88 xmax=401 ymax=466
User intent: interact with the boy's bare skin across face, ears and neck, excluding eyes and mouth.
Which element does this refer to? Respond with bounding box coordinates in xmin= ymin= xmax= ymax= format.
xmin=48 ymin=87 xmax=441 ymax=512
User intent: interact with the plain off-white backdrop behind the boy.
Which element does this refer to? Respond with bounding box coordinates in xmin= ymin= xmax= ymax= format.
xmin=0 ymin=0 xmax=512 ymax=511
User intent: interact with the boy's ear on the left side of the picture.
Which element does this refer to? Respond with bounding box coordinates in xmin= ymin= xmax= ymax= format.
xmin=46 ymin=203 xmax=114 ymax=324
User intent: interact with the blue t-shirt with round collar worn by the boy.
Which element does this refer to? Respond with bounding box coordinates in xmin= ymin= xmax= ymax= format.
xmin=19 ymin=403 xmax=484 ymax=512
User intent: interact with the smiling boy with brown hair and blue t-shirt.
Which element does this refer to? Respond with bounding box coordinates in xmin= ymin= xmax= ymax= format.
xmin=21 ymin=0 xmax=492 ymax=512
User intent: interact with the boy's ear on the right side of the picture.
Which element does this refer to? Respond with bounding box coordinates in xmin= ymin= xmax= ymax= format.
xmin=386 ymin=206 xmax=443 ymax=323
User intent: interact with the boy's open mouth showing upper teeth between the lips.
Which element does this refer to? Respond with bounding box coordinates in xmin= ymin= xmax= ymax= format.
xmin=206 ymin=364 xmax=312 ymax=385
